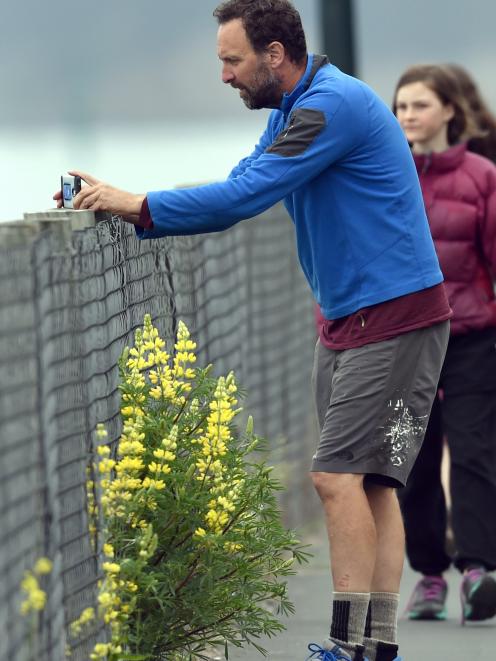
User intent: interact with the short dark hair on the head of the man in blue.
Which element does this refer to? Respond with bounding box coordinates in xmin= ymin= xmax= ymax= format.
xmin=214 ymin=0 xmax=307 ymax=64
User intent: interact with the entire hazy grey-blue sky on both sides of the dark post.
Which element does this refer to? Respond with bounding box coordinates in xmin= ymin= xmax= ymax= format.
xmin=0 ymin=0 xmax=496 ymax=128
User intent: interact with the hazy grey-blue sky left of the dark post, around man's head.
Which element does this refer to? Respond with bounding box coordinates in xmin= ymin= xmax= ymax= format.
xmin=0 ymin=0 xmax=318 ymax=124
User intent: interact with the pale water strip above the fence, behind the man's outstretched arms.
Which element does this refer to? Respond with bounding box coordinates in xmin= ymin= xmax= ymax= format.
xmin=0 ymin=118 xmax=267 ymax=221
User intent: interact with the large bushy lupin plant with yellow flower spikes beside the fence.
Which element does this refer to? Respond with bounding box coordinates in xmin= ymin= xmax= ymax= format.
xmin=78 ymin=316 xmax=308 ymax=661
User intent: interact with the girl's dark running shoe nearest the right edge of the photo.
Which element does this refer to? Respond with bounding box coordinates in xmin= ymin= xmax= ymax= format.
xmin=460 ymin=567 xmax=496 ymax=624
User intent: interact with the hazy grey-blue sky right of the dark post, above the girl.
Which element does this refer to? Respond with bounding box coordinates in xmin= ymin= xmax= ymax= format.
xmin=354 ymin=0 xmax=496 ymax=111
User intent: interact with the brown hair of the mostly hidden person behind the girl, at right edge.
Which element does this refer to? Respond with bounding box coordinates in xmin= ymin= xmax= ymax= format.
xmin=444 ymin=63 xmax=496 ymax=163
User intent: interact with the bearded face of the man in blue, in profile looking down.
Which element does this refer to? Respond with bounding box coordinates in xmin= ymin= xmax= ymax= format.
xmin=217 ymin=19 xmax=282 ymax=110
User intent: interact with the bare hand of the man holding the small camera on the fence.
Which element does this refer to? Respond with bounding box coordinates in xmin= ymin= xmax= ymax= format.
xmin=53 ymin=170 xmax=145 ymax=216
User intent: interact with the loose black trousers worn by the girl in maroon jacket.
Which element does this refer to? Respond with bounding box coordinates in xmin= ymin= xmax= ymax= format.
xmin=398 ymin=329 xmax=496 ymax=574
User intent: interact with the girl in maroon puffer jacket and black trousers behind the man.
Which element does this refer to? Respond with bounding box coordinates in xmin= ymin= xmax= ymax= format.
xmin=393 ymin=65 xmax=496 ymax=622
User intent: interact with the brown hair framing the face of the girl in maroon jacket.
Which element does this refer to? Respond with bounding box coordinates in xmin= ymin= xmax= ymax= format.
xmin=393 ymin=64 xmax=481 ymax=145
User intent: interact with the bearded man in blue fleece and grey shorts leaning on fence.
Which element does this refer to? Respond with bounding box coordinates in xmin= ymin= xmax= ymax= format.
xmin=56 ymin=0 xmax=451 ymax=661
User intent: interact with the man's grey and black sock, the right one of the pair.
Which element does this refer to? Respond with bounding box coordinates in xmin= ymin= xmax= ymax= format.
xmin=363 ymin=592 xmax=400 ymax=661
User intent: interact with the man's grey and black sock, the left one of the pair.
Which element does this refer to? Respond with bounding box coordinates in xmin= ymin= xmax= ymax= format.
xmin=330 ymin=592 xmax=370 ymax=658
